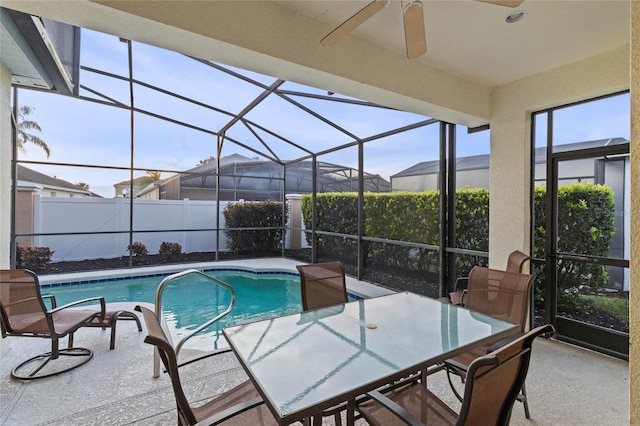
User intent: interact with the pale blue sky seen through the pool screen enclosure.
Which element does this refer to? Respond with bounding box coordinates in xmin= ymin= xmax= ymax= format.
xmin=13 ymin=29 xmax=630 ymax=197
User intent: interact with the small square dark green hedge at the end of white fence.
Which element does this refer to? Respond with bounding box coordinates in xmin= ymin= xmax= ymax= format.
xmin=223 ymin=200 xmax=288 ymax=254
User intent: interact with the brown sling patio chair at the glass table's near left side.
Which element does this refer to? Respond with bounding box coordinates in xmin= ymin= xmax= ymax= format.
xmin=135 ymin=306 xmax=277 ymax=426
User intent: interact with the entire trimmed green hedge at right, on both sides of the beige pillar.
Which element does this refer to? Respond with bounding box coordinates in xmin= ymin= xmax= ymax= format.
xmin=301 ymin=183 xmax=615 ymax=297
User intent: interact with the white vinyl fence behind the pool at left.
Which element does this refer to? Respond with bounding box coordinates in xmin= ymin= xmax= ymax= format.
xmin=33 ymin=195 xmax=302 ymax=262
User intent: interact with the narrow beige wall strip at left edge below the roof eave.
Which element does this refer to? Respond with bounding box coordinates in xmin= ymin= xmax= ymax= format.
xmin=0 ymin=64 xmax=12 ymax=269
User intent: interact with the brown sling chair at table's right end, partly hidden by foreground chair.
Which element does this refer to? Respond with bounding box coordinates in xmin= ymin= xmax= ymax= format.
xmin=445 ymin=266 xmax=534 ymax=418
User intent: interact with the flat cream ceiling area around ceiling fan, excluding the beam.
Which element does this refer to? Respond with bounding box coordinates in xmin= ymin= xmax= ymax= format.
xmin=280 ymin=0 xmax=630 ymax=86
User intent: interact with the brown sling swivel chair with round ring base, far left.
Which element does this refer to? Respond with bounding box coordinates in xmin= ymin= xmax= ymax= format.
xmin=0 ymin=269 xmax=105 ymax=380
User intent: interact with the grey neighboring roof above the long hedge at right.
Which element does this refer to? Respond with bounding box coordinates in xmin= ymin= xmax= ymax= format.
xmin=391 ymin=138 xmax=629 ymax=179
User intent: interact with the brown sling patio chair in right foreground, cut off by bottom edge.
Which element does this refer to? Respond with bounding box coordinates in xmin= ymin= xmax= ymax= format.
xmin=357 ymin=324 xmax=554 ymax=426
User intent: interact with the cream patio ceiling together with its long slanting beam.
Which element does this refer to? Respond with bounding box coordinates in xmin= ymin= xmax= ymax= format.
xmin=2 ymin=0 xmax=630 ymax=127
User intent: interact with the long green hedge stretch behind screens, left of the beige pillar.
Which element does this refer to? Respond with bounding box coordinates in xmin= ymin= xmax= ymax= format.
xmin=301 ymin=189 xmax=489 ymax=272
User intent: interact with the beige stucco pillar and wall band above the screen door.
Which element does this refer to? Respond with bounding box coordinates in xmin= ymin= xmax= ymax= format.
xmin=489 ymin=47 xmax=629 ymax=268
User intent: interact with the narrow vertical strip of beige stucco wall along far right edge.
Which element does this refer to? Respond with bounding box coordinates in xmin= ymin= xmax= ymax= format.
xmin=629 ymin=1 xmax=640 ymax=425
